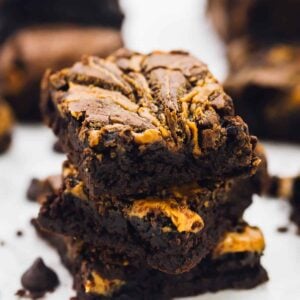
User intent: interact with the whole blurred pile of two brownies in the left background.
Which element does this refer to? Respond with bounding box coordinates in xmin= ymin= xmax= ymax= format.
xmin=0 ymin=0 xmax=123 ymax=121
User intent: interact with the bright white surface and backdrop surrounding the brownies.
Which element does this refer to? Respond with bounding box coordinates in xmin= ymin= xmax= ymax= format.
xmin=0 ymin=0 xmax=300 ymax=300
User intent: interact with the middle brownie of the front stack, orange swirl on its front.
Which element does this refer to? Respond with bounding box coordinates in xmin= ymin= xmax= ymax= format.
xmin=38 ymin=145 xmax=268 ymax=273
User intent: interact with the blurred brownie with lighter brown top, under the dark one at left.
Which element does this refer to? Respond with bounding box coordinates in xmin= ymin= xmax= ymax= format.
xmin=0 ymin=24 xmax=123 ymax=121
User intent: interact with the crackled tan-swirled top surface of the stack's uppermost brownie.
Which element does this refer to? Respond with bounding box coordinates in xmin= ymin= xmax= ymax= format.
xmin=43 ymin=49 xmax=247 ymax=157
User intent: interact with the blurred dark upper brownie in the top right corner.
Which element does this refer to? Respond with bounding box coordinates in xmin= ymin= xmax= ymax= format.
xmin=208 ymin=0 xmax=300 ymax=42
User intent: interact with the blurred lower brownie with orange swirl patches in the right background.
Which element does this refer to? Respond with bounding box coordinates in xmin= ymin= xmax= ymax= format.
xmin=224 ymin=40 xmax=300 ymax=142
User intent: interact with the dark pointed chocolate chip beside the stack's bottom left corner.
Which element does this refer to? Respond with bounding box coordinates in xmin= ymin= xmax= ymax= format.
xmin=21 ymin=258 xmax=59 ymax=298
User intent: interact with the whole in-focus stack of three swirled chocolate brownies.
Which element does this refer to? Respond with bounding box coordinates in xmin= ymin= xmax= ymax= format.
xmin=36 ymin=49 xmax=267 ymax=299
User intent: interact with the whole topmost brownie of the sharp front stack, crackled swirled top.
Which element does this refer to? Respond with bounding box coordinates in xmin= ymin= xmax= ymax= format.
xmin=41 ymin=49 xmax=260 ymax=199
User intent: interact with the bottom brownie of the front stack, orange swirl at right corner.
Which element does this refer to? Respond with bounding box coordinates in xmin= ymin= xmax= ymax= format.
xmin=35 ymin=223 xmax=268 ymax=300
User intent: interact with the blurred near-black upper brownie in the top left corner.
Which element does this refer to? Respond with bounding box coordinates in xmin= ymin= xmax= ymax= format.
xmin=0 ymin=0 xmax=123 ymax=42
